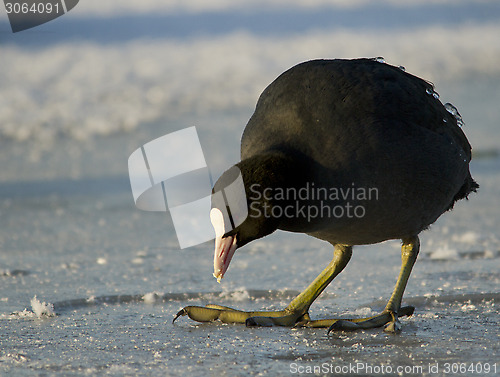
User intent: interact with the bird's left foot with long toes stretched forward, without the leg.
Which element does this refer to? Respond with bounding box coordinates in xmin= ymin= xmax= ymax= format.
xmin=172 ymin=304 xmax=309 ymax=327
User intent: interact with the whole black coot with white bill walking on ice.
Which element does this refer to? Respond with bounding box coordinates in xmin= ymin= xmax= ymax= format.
xmin=174 ymin=59 xmax=479 ymax=332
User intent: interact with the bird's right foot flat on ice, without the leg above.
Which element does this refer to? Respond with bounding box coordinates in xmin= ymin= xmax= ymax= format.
xmin=324 ymin=306 xmax=415 ymax=333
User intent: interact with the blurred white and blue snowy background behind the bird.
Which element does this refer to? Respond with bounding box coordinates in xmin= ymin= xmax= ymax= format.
xmin=0 ymin=0 xmax=500 ymax=181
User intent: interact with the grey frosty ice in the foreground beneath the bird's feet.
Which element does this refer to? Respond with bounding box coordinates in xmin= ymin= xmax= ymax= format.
xmin=0 ymin=119 xmax=500 ymax=376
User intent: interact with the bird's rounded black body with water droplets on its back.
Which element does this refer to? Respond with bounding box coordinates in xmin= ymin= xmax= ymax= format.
xmin=233 ymin=59 xmax=477 ymax=245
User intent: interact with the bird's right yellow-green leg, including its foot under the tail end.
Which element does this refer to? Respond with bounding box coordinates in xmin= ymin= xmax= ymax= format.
xmin=326 ymin=236 xmax=420 ymax=333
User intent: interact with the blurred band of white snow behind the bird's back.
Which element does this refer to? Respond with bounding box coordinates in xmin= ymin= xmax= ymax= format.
xmin=0 ymin=18 xmax=500 ymax=146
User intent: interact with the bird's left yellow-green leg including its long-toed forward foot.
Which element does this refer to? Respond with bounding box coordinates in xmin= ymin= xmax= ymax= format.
xmin=174 ymin=245 xmax=352 ymax=327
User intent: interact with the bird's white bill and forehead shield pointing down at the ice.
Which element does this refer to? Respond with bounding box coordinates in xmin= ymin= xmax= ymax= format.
xmin=210 ymin=208 xmax=237 ymax=283
